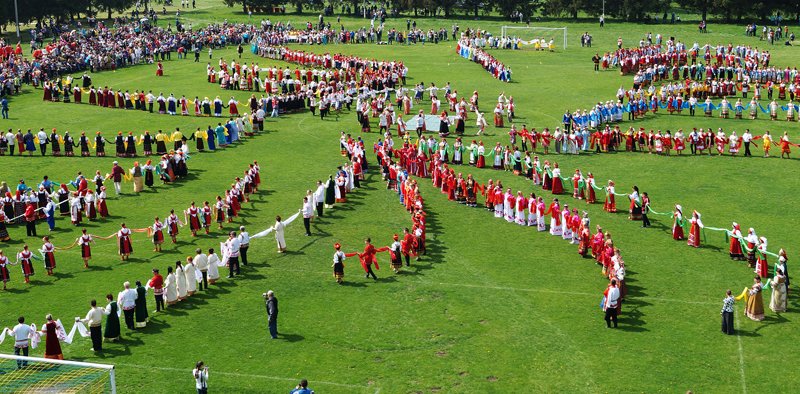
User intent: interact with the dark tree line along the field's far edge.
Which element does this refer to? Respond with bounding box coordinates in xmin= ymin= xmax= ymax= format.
xmin=0 ymin=0 xmax=800 ymax=26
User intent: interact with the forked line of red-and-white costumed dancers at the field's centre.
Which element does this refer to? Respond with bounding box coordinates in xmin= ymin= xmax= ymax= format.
xmin=360 ymin=133 xmax=627 ymax=327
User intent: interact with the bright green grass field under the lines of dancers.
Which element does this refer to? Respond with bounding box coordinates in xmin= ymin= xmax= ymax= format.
xmin=0 ymin=2 xmax=800 ymax=393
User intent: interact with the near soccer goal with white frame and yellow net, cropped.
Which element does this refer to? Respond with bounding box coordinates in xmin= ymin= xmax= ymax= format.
xmin=0 ymin=354 xmax=117 ymax=394
